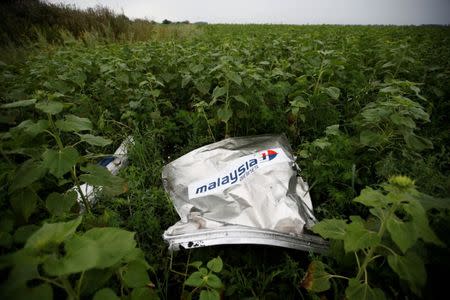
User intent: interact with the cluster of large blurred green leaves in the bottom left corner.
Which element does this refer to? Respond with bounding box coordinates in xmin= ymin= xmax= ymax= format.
xmin=0 ymin=217 xmax=151 ymax=299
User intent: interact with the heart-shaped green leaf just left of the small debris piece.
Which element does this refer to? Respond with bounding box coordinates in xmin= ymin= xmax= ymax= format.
xmin=42 ymin=147 xmax=80 ymax=178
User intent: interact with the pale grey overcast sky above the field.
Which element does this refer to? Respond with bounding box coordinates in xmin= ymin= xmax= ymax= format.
xmin=48 ymin=0 xmax=450 ymax=25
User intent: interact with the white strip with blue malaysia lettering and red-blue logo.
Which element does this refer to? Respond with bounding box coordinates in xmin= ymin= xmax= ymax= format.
xmin=188 ymin=148 xmax=290 ymax=199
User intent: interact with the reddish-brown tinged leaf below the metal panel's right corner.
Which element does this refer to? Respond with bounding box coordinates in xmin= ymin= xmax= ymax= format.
xmin=301 ymin=260 xmax=331 ymax=293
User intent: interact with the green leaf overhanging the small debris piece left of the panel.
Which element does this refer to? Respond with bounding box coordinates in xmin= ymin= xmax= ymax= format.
xmin=80 ymin=165 xmax=127 ymax=196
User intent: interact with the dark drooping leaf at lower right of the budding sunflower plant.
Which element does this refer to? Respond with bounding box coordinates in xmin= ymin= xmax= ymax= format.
xmin=388 ymin=251 xmax=427 ymax=295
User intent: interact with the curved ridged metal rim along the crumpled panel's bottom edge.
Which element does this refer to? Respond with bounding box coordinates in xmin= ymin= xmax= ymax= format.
xmin=163 ymin=225 xmax=328 ymax=254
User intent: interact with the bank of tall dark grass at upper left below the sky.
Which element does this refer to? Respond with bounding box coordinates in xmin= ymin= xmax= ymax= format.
xmin=0 ymin=0 xmax=200 ymax=47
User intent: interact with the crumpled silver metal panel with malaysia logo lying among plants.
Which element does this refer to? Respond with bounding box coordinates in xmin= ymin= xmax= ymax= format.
xmin=162 ymin=135 xmax=326 ymax=252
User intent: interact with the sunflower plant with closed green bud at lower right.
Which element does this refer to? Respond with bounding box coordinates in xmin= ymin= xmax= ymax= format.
xmin=303 ymin=176 xmax=445 ymax=299
